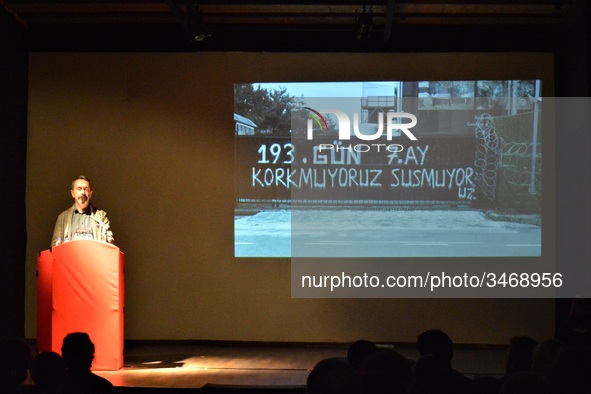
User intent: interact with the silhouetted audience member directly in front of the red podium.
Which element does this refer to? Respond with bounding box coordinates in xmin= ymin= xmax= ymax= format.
xmin=62 ymin=332 xmax=113 ymax=393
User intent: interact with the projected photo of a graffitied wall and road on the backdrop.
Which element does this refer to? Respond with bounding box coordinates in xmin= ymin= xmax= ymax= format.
xmin=234 ymin=80 xmax=542 ymax=258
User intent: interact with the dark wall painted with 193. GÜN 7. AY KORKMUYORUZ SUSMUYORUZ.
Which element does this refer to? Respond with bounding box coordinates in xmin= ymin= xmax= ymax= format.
xmin=235 ymin=136 xmax=478 ymax=205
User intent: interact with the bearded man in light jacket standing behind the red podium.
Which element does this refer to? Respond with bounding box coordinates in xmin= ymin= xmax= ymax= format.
xmin=51 ymin=175 xmax=114 ymax=247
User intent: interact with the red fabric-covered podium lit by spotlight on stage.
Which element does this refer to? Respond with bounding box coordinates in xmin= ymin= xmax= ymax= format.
xmin=37 ymin=240 xmax=124 ymax=371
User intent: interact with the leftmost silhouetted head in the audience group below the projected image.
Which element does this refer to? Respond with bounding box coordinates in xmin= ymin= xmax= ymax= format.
xmin=306 ymin=357 xmax=361 ymax=394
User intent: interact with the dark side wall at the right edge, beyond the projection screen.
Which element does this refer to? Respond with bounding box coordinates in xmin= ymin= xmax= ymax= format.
xmin=555 ymin=1 xmax=591 ymax=329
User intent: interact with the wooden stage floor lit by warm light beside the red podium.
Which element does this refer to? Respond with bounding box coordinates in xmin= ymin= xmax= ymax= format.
xmin=95 ymin=344 xmax=506 ymax=389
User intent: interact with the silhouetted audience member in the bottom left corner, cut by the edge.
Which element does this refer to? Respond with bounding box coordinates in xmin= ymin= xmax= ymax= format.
xmin=0 ymin=338 xmax=33 ymax=394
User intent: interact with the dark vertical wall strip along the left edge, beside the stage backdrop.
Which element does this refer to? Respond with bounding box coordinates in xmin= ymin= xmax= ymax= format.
xmin=0 ymin=7 xmax=28 ymax=337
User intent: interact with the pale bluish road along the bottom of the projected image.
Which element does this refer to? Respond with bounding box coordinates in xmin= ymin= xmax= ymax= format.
xmin=234 ymin=207 xmax=542 ymax=258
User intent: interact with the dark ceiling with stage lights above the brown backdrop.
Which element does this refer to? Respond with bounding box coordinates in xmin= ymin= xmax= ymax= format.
xmin=0 ymin=0 xmax=573 ymax=52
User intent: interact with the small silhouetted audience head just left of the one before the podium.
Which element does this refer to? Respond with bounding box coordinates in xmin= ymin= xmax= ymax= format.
xmin=31 ymin=352 xmax=66 ymax=394
